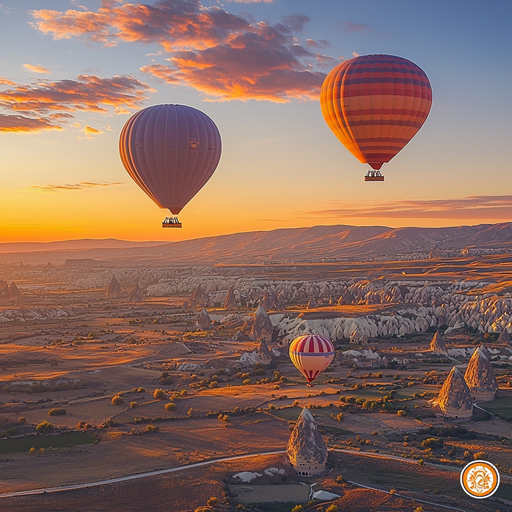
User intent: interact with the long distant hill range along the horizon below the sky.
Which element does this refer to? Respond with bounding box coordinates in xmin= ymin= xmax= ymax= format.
xmin=0 ymin=223 xmax=512 ymax=264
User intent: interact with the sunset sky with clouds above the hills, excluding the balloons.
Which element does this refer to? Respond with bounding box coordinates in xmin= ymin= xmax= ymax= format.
xmin=0 ymin=0 xmax=512 ymax=242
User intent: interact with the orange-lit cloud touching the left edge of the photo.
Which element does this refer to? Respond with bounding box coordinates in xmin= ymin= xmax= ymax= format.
xmin=0 ymin=75 xmax=153 ymax=135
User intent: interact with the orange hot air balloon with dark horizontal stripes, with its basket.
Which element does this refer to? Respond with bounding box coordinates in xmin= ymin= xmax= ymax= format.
xmin=320 ymin=55 xmax=432 ymax=181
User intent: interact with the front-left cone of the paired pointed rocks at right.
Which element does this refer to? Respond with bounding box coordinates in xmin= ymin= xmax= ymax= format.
xmin=437 ymin=366 xmax=473 ymax=420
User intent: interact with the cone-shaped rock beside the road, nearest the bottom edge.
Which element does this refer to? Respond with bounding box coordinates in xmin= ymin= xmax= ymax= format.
xmin=287 ymin=407 xmax=327 ymax=476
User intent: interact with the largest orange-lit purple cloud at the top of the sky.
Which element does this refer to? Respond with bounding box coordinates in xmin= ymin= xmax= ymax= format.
xmin=32 ymin=0 xmax=330 ymax=102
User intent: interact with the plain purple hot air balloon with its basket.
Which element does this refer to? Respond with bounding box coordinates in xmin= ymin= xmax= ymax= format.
xmin=119 ymin=105 xmax=222 ymax=228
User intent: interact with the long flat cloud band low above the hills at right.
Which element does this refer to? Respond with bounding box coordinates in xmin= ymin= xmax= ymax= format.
xmin=302 ymin=195 xmax=512 ymax=220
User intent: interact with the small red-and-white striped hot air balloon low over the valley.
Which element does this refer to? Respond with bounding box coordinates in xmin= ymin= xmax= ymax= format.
xmin=290 ymin=334 xmax=334 ymax=386
